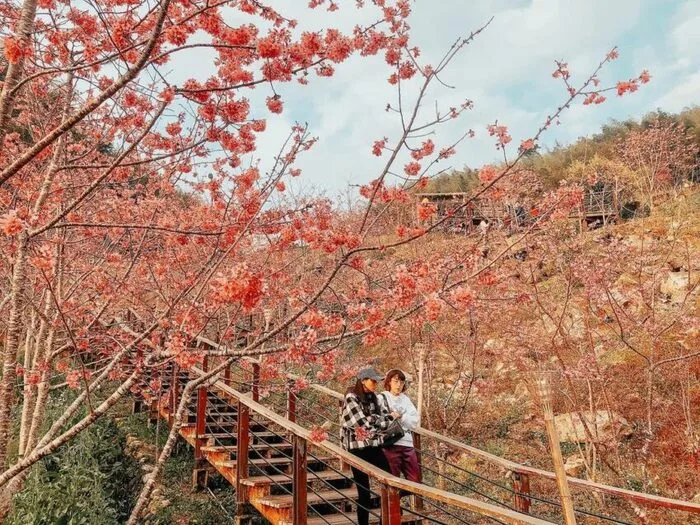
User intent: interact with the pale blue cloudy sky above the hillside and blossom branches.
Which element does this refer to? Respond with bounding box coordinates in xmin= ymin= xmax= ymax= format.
xmin=174 ymin=0 xmax=700 ymax=197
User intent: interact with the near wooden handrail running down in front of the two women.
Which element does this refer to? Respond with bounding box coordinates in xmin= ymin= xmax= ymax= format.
xmin=190 ymin=367 xmax=551 ymax=525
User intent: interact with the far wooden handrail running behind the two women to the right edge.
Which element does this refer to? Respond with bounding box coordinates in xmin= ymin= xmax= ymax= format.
xmin=120 ymin=309 xmax=700 ymax=514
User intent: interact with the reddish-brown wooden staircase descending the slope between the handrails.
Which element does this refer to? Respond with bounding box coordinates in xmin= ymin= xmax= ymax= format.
xmin=136 ymin=364 xmax=430 ymax=525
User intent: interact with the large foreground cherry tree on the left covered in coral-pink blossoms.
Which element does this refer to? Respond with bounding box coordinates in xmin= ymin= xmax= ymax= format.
xmin=0 ymin=0 xmax=652 ymax=522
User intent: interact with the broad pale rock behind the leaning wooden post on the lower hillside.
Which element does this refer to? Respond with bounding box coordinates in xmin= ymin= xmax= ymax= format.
xmin=554 ymin=410 xmax=632 ymax=443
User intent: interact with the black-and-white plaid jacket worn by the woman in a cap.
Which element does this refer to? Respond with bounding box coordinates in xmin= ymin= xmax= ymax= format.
xmin=340 ymin=392 xmax=391 ymax=450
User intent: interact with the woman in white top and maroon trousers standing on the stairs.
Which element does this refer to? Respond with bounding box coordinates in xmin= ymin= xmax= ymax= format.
xmin=378 ymin=368 xmax=421 ymax=482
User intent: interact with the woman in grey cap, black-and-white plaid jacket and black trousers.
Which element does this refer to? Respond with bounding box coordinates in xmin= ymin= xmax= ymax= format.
xmin=341 ymin=368 xmax=400 ymax=525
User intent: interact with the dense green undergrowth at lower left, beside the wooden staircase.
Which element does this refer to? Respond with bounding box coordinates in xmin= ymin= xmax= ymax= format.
xmin=5 ymin=392 xmax=241 ymax=525
